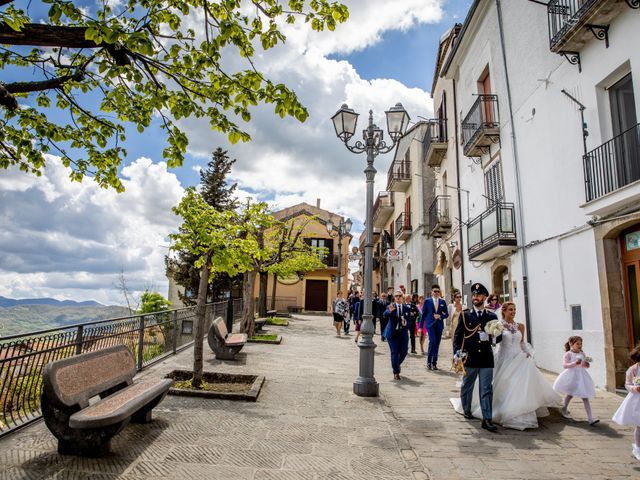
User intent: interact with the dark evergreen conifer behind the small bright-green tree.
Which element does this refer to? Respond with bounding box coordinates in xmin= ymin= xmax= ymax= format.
xmin=165 ymin=147 xmax=240 ymax=305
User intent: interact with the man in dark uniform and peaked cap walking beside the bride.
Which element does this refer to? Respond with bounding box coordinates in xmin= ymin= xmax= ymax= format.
xmin=453 ymin=283 xmax=502 ymax=432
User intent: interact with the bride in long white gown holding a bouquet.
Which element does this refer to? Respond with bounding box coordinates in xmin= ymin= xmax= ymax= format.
xmin=450 ymin=302 xmax=560 ymax=430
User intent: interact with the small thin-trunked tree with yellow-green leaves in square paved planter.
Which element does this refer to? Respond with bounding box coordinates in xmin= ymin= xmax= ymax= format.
xmin=170 ymin=187 xmax=273 ymax=388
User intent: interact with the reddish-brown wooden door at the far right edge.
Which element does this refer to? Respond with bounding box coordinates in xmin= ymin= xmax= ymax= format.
xmin=620 ymin=225 xmax=640 ymax=349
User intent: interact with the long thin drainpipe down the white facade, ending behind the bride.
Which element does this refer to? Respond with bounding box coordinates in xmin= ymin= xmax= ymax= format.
xmin=496 ymin=0 xmax=533 ymax=344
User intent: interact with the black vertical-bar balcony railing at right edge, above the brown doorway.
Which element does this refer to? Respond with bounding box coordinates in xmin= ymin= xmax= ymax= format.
xmin=583 ymin=124 xmax=640 ymax=202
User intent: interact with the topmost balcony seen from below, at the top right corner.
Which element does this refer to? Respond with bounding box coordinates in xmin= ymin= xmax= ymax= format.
xmin=547 ymin=0 xmax=638 ymax=54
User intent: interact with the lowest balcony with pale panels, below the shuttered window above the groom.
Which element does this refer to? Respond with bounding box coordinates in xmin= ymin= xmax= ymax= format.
xmin=467 ymin=203 xmax=517 ymax=260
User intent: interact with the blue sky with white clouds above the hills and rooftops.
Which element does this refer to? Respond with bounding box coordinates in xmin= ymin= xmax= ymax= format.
xmin=0 ymin=0 xmax=471 ymax=304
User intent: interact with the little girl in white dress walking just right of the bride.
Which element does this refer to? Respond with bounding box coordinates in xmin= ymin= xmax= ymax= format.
xmin=553 ymin=335 xmax=600 ymax=425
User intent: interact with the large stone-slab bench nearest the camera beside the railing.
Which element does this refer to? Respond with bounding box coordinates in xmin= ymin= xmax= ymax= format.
xmin=41 ymin=345 xmax=173 ymax=457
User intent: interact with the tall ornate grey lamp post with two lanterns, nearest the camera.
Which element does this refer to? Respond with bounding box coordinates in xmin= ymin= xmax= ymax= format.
xmin=331 ymin=103 xmax=409 ymax=397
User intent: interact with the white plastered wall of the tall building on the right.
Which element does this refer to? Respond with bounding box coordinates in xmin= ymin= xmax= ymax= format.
xmin=450 ymin=1 xmax=640 ymax=386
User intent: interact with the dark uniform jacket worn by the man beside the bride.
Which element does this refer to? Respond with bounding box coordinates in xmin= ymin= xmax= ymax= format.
xmin=453 ymin=309 xmax=502 ymax=368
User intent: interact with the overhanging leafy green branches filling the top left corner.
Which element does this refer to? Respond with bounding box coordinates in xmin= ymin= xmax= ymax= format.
xmin=0 ymin=0 xmax=348 ymax=191
